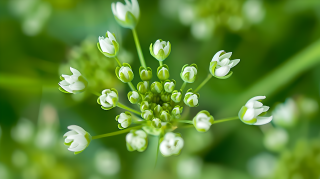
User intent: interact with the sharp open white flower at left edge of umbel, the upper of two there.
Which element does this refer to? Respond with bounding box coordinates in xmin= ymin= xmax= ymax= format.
xmin=59 ymin=67 xmax=88 ymax=93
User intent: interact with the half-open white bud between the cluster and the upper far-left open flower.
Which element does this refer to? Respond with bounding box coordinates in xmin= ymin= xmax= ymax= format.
xmin=97 ymin=88 xmax=119 ymax=110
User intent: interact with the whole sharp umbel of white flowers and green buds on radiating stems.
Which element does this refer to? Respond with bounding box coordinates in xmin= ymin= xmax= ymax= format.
xmin=59 ymin=0 xmax=272 ymax=156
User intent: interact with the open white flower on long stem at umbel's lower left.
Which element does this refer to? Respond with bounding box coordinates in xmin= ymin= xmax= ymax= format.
xmin=63 ymin=125 xmax=91 ymax=154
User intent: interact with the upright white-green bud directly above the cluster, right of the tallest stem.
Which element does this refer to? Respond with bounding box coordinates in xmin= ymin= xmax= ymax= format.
xmin=149 ymin=39 xmax=171 ymax=61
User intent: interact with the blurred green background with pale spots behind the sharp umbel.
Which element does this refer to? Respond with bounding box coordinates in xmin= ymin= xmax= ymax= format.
xmin=0 ymin=0 xmax=320 ymax=179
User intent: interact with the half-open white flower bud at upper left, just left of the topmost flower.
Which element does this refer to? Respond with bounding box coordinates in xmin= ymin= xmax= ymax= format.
xmin=97 ymin=31 xmax=119 ymax=58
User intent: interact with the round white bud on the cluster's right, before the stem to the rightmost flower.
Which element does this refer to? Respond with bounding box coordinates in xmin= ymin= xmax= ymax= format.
xmin=193 ymin=110 xmax=214 ymax=132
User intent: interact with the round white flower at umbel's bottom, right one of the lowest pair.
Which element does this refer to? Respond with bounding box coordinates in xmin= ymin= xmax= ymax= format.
xmin=159 ymin=132 xmax=184 ymax=157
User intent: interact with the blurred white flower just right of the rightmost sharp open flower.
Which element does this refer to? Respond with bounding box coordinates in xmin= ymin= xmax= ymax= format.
xmin=272 ymin=98 xmax=298 ymax=127
